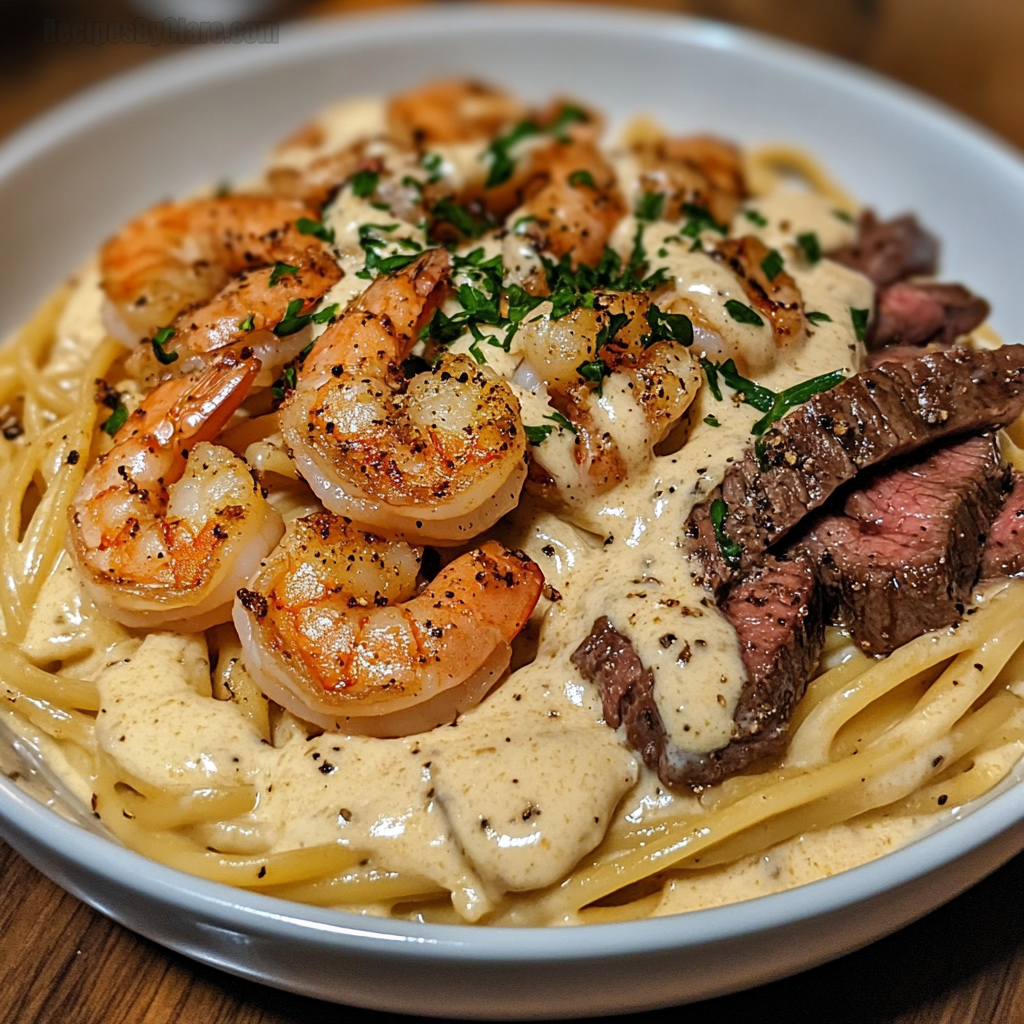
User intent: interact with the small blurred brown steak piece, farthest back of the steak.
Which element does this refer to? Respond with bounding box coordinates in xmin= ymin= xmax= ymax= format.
xmin=825 ymin=210 xmax=939 ymax=288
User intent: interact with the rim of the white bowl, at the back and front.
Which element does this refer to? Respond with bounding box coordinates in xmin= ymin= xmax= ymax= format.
xmin=0 ymin=5 xmax=1024 ymax=962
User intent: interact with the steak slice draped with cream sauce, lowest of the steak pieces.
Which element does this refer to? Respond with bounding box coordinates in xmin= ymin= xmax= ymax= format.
xmin=572 ymin=557 xmax=825 ymax=790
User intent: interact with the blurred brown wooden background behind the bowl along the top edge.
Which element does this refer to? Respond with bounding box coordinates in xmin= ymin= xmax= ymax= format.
xmin=0 ymin=0 xmax=1024 ymax=148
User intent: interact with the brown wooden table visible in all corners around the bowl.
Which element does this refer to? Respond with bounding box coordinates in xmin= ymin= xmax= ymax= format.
xmin=0 ymin=0 xmax=1024 ymax=1024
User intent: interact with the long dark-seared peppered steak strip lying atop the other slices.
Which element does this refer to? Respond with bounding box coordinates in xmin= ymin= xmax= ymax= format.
xmin=686 ymin=345 xmax=1024 ymax=591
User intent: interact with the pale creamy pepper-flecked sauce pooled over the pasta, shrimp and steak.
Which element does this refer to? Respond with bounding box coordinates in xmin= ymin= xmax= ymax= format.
xmin=8 ymin=100 xmax=966 ymax=924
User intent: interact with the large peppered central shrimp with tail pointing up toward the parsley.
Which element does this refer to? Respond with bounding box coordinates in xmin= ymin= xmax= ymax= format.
xmin=280 ymin=249 xmax=526 ymax=544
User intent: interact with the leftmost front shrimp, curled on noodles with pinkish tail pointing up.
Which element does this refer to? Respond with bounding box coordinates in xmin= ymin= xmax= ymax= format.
xmin=69 ymin=353 xmax=283 ymax=631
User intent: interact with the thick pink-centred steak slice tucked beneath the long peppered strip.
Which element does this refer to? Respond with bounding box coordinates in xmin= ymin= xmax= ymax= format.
xmin=798 ymin=434 xmax=1007 ymax=654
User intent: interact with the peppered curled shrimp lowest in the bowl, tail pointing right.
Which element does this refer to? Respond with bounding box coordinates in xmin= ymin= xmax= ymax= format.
xmin=233 ymin=513 xmax=544 ymax=736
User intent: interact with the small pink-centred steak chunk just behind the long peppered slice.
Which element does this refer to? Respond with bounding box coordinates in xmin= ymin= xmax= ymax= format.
xmin=865 ymin=283 xmax=989 ymax=349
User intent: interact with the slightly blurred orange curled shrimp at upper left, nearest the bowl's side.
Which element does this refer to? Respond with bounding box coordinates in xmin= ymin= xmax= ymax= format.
xmin=99 ymin=196 xmax=340 ymax=348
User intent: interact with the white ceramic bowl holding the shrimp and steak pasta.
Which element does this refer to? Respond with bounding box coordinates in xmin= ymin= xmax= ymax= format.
xmin=0 ymin=6 xmax=1024 ymax=1018
